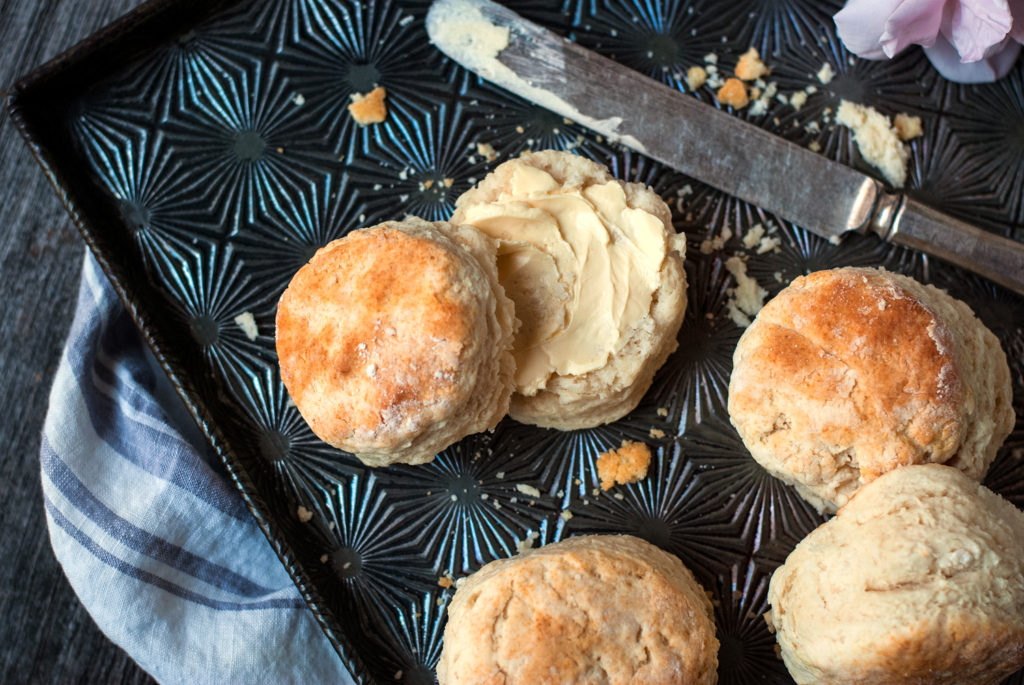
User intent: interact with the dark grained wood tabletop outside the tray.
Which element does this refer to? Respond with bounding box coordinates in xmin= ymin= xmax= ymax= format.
xmin=0 ymin=0 xmax=154 ymax=683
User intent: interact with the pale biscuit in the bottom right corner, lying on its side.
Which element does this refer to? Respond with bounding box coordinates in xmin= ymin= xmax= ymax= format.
xmin=766 ymin=464 xmax=1024 ymax=685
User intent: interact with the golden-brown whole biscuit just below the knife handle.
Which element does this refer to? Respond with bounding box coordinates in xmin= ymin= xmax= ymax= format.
xmin=728 ymin=268 xmax=1014 ymax=511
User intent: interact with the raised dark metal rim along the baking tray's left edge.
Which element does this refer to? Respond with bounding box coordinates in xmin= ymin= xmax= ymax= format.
xmin=4 ymin=0 xmax=371 ymax=683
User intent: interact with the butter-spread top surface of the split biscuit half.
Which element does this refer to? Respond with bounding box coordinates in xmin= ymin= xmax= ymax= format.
xmin=452 ymin=151 xmax=681 ymax=395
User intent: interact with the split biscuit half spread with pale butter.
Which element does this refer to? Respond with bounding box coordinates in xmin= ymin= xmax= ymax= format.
xmin=452 ymin=151 xmax=686 ymax=429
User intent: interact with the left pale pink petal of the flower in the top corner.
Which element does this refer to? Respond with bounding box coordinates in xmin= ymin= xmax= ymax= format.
xmin=834 ymin=0 xmax=946 ymax=59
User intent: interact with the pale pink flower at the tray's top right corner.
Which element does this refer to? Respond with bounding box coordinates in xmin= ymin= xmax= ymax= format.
xmin=835 ymin=0 xmax=1024 ymax=83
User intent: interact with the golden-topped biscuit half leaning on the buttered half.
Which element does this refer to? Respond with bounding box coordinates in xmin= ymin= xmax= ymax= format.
xmin=276 ymin=217 xmax=515 ymax=466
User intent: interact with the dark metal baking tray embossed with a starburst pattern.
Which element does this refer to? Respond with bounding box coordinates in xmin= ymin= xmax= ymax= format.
xmin=9 ymin=0 xmax=1024 ymax=683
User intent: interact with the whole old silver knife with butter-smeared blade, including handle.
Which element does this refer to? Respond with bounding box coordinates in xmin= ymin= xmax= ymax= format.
xmin=427 ymin=0 xmax=1024 ymax=295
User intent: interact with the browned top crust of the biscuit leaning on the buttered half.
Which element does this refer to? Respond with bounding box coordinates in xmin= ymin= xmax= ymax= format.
xmin=278 ymin=224 xmax=476 ymax=446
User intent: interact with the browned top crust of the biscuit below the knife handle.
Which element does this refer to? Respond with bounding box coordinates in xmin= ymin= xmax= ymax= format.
xmin=729 ymin=268 xmax=973 ymax=482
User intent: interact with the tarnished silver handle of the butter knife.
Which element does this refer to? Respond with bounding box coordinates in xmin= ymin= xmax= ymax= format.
xmin=872 ymin=196 xmax=1024 ymax=295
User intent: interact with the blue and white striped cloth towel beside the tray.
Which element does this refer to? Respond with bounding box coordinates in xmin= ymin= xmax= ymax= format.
xmin=40 ymin=256 xmax=352 ymax=683
